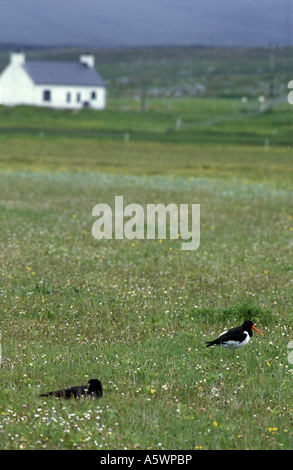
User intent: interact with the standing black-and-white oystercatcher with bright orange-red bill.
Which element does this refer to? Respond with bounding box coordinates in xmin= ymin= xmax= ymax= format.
xmin=206 ymin=320 xmax=263 ymax=355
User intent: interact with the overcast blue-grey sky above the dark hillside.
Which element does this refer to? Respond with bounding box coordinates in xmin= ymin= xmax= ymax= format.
xmin=0 ymin=0 xmax=293 ymax=47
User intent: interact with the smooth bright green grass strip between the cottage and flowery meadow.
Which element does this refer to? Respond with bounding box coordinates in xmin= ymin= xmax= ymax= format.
xmin=0 ymin=97 xmax=293 ymax=149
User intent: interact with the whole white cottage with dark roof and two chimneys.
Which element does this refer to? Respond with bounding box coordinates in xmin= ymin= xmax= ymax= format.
xmin=0 ymin=52 xmax=107 ymax=109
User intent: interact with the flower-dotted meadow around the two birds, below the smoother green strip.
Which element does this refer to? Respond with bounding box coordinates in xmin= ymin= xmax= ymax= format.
xmin=0 ymin=140 xmax=293 ymax=449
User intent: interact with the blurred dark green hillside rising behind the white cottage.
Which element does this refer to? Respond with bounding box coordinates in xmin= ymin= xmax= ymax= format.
xmin=0 ymin=46 xmax=293 ymax=101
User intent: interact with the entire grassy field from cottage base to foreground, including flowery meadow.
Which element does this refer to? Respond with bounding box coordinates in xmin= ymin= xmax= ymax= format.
xmin=0 ymin=46 xmax=293 ymax=450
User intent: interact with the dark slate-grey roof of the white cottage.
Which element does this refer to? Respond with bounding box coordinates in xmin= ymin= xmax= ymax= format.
xmin=23 ymin=60 xmax=106 ymax=86
